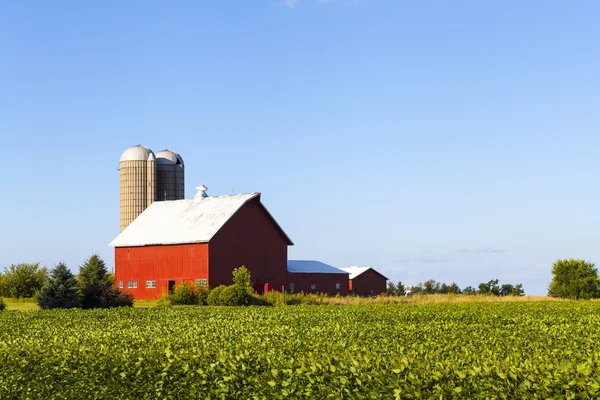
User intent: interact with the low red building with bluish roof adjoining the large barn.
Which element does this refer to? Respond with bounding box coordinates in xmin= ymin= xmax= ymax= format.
xmin=287 ymin=260 xmax=348 ymax=296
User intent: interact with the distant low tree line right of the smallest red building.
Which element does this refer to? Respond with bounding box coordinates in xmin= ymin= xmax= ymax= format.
xmin=387 ymin=279 xmax=525 ymax=296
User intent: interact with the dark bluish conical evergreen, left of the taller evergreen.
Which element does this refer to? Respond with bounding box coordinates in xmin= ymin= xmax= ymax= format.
xmin=37 ymin=263 xmax=79 ymax=309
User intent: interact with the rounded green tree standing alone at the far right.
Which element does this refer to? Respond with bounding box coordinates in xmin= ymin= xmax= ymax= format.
xmin=548 ymin=258 xmax=600 ymax=299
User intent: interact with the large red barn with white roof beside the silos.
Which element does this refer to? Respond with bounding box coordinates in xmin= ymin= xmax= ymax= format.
xmin=110 ymin=187 xmax=293 ymax=300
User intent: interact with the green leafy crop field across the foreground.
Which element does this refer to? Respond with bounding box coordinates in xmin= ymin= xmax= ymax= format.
xmin=0 ymin=302 xmax=600 ymax=399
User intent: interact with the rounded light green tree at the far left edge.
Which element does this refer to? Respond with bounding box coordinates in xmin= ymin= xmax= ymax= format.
xmin=3 ymin=263 xmax=48 ymax=298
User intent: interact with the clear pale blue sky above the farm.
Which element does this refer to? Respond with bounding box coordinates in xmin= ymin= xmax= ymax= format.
xmin=0 ymin=0 xmax=600 ymax=294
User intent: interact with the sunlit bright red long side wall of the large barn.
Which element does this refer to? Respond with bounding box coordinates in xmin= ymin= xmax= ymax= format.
xmin=115 ymin=243 xmax=210 ymax=300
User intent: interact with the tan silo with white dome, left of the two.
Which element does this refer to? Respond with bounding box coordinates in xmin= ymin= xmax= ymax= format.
xmin=119 ymin=145 xmax=156 ymax=232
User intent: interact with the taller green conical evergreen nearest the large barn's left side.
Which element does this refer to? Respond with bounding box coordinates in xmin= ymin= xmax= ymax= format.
xmin=77 ymin=254 xmax=133 ymax=308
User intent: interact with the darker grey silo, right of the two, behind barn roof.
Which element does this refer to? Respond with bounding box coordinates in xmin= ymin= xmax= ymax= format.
xmin=156 ymin=150 xmax=185 ymax=201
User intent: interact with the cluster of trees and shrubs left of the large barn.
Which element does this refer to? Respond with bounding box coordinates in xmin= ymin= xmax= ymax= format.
xmin=0 ymin=254 xmax=133 ymax=309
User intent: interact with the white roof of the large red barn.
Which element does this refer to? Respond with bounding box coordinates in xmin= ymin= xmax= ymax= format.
xmin=110 ymin=192 xmax=293 ymax=247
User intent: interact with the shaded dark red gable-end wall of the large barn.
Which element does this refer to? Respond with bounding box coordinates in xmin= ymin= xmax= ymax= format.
xmin=210 ymin=199 xmax=288 ymax=290
